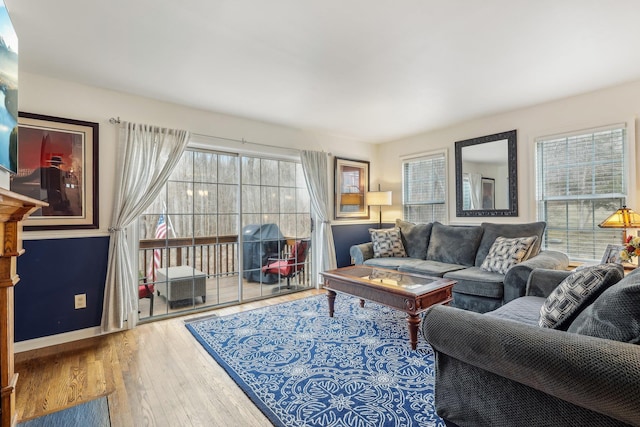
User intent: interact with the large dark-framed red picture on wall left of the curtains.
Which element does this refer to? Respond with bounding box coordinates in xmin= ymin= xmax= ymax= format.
xmin=11 ymin=112 xmax=99 ymax=230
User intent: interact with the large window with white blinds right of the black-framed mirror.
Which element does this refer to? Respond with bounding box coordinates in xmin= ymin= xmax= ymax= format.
xmin=536 ymin=125 xmax=629 ymax=261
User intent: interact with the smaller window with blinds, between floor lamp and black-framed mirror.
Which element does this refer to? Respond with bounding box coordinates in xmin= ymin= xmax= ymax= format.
xmin=402 ymin=153 xmax=447 ymax=223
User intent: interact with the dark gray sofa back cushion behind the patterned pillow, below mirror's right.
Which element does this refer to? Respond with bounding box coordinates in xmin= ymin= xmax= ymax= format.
xmin=474 ymin=221 xmax=547 ymax=267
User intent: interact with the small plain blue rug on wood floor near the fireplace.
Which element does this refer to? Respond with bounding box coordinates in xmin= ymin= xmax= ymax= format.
xmin=18 ymin=396 xmax=111 ymax=427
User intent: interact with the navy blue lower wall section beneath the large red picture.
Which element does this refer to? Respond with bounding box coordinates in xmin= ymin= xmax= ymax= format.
xmin=15 ymin=237 xmax=109 ymax=342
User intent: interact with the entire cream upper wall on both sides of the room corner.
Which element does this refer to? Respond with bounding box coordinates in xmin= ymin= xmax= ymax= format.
xmin=19 ymin=73 xmax=640 ymax=232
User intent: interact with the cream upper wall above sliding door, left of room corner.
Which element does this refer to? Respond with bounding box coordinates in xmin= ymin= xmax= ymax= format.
xmin=18 ymin=72 xmax=378 ymax=239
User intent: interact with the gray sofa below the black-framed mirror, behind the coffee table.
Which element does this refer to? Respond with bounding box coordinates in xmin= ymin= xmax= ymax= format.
xmin=350 ymin=220 xmax=569 ymax=313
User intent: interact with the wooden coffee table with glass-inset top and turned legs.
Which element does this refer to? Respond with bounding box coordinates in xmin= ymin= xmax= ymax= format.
xmin=320 ymin=265 xmax=456 ymax=350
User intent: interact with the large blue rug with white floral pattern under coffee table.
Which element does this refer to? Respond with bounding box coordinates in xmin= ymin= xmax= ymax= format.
xmin=187 ymin=294 xmax=444 ymax=427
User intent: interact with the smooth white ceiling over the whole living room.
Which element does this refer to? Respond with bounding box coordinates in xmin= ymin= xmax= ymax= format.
xmin=5 ymin=0 xmax=640 ymax=142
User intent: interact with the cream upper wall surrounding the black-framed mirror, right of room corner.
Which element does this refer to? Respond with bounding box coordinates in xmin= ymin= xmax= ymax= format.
xmin=378 ymin=81 xmax=640 ymax=224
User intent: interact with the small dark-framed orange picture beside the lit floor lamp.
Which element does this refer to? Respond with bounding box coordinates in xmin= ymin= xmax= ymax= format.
xmin=334 ymin=157 xmax=369 ymax=219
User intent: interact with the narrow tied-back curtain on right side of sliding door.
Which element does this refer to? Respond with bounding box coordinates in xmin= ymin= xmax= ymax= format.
xmin=300 ymin=150 xmax=337 ymax=280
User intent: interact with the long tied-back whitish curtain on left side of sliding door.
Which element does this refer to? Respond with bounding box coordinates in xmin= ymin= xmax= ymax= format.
xmin=102 ymin=122 xmax=189 ymax=332
